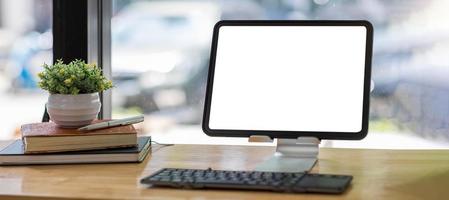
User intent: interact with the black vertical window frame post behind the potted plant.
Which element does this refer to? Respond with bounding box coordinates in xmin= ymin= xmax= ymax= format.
xmin=49 ymin=0 xmax=112 ymax=121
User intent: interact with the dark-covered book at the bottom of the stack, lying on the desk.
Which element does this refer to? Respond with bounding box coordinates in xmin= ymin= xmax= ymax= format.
xmin=0 ymin=136 xmax=151 ymax=165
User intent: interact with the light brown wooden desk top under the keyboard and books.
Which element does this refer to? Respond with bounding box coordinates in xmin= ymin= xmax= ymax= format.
xmin=0 ymin=142 xmax=449 ymax=200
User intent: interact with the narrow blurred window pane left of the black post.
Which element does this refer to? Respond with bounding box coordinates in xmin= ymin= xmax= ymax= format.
xmin=0 ymin=0 xmax=52 ymax=139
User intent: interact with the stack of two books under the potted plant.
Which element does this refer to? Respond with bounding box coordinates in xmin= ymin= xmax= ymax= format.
xmin=0 ymin=122 xmax=151 ymax=165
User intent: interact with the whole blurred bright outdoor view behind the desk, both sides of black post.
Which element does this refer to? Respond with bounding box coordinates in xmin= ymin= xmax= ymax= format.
xmin=0 ymin=0 xmax=449 ymax=149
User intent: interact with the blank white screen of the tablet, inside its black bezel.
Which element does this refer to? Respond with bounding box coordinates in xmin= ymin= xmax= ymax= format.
xmin=209 ymin=26 xmax=366 ymax=132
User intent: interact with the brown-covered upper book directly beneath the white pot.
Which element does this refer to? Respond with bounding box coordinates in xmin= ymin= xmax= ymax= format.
xmin=21 ymin=122 xmax=137 ymax=154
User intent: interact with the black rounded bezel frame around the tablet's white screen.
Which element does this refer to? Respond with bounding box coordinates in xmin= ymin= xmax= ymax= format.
xmin=202 ymin=20 xmax=373 ymax=140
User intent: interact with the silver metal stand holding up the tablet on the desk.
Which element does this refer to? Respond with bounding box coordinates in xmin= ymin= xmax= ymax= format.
xmin=249 ymin=136 xmax=320 ymax=172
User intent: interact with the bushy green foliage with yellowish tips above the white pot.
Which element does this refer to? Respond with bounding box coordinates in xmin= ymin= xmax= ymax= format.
xmin=38 ymin=60 xmax=113 ymax=95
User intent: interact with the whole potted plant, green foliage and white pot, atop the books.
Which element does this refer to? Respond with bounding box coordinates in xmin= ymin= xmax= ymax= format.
xmin=38 ymin=60 xmax=112 ymax=128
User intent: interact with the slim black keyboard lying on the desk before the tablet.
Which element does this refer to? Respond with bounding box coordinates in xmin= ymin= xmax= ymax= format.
xmin=141 ymin=168 xmax=352 ymax=193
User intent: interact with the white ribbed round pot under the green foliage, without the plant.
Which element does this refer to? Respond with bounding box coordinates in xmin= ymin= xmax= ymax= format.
xmin=47 ymin=93 xmax=101 ymax=128
